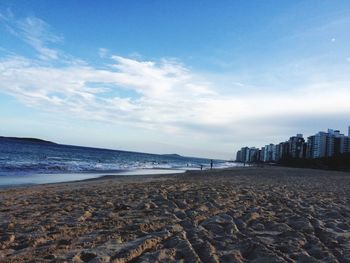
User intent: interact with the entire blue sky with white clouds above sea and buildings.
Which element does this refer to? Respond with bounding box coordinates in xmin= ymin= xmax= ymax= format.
xmin=0 ymin=0 xmax=350 ymax=159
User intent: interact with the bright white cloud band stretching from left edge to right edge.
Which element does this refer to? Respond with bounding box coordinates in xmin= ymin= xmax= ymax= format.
xmin=0 ymin=56 xmax=350 ymax=134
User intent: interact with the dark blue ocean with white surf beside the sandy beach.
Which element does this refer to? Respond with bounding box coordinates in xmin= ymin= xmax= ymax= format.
xmin=0 ymin=137 xmax=237 ymax=186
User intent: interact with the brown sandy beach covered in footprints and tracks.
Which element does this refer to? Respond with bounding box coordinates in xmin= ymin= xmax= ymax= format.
xmin=0 ymin=167 xmax=350 ymax=263
